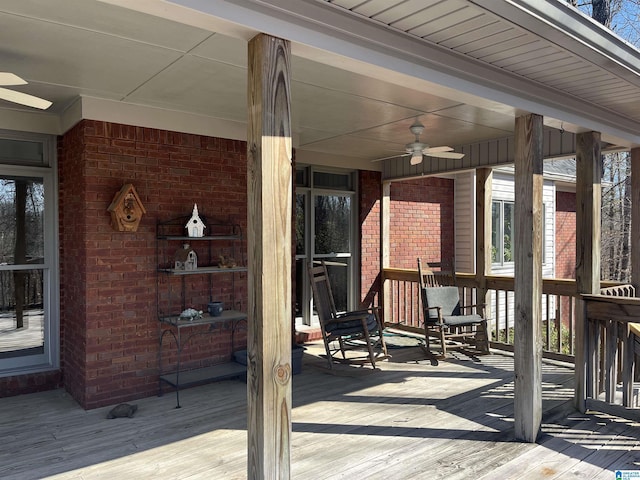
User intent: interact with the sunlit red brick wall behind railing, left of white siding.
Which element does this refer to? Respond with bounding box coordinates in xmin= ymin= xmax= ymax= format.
xmin=391 ymin=177 xmax=455 ymax=269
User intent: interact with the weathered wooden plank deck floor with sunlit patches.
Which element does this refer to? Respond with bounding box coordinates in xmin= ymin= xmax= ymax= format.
xmin=0 ymin=346 xmax=640 ymax=480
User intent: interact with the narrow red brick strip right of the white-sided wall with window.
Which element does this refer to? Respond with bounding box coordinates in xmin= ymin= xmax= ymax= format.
xmin=555 ymin=192 xmax=576 ymax=278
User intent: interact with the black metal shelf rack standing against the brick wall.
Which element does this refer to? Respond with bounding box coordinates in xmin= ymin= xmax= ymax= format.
xmin=156 ymin=217 xmax=247 ymax=408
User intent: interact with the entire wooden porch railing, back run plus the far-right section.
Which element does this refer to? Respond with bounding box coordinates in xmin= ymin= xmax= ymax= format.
xmin=383 ymin=268 xmax=640 ymax=408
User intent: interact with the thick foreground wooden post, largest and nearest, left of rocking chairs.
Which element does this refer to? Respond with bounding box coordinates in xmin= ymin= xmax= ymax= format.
xmin=247 ymin=34 xmax=292 ymax=479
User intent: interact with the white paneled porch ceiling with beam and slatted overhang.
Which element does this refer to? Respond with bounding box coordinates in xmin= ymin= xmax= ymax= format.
xmin=0 ymin=0 xmax=640 ymax=168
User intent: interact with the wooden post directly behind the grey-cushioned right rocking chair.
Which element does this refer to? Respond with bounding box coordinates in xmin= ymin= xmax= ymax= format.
xmin=476 ymin=168 xmax=493 ymax=317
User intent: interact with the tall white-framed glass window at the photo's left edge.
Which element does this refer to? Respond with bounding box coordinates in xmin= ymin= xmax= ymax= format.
xmin=0 ymin=131 xmax=59 ymax=376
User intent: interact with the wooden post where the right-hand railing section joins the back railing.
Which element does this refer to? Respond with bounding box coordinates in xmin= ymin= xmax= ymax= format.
xmin=575 ymin=132 xmax=602 ymax=412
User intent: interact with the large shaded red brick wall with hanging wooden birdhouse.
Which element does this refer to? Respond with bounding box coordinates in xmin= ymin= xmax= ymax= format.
xmin=59 ymin=120 xmax=247 ymax=408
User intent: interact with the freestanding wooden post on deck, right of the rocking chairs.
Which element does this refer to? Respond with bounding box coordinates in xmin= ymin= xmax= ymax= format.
xmin=513 ymin=114 xmax=543 ymax=442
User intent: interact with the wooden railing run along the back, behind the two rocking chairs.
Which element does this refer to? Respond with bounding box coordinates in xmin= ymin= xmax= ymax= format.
xmin=384 ymin=268 xmax=576 ymax=362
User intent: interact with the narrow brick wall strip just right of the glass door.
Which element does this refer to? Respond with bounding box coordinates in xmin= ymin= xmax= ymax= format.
xmin=358 ymin=171 xmax=382 ymax=307
